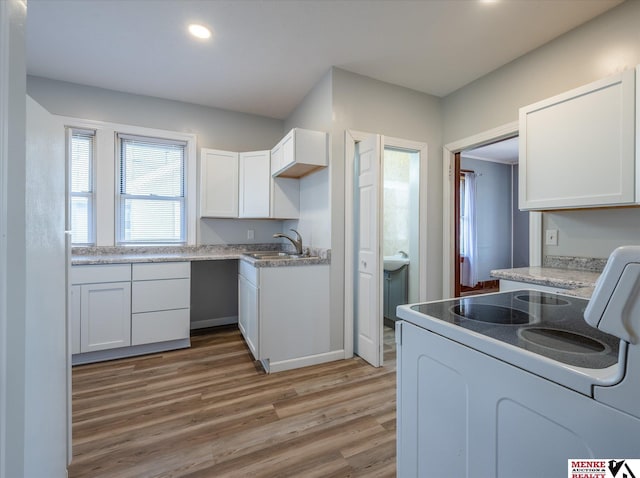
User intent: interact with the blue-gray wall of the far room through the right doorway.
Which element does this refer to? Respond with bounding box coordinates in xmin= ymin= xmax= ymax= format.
xmin=461 ymin=156 xmax=512 ymax=281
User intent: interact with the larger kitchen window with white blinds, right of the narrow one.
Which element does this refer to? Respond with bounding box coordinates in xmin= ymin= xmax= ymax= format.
xmin=116 ymin=134 xmax=187 ymax=244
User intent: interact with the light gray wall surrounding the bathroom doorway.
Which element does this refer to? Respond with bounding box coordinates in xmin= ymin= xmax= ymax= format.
xmin=331 ymin=68 xmax=442 ymax=304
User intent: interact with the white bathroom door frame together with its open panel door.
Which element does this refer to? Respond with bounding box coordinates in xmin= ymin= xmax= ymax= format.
xmin=344 ymin=131 xmax=428 ymax=366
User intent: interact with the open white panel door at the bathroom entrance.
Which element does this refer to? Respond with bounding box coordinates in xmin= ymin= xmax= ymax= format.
xmin=355 ymin=135 xmax=383 ymax=367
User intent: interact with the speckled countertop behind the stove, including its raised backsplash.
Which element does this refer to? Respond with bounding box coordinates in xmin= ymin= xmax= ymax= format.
xmin=491 ymin=256 xmax=607 ymax=299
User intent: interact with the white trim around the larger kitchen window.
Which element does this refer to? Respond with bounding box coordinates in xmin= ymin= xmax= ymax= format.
xmin=59 ymin=116 xmax=198 ymax=246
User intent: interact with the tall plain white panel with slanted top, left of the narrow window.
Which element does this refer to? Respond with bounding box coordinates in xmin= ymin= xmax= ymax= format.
xmin=24 ymin=97 xmax=71 ymax=477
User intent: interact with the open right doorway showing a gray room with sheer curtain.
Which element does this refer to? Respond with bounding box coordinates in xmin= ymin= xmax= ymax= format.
xmin=453 ymin=136 xmax=529 ymax=297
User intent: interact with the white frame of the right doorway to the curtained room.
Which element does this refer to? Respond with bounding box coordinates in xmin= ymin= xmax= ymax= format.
xmin=442 ymin=121 xmax=542 ymax=298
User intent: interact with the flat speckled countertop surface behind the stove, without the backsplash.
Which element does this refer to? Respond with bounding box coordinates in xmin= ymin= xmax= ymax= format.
xmin=491 ymin=267 xmax=600 ymax=299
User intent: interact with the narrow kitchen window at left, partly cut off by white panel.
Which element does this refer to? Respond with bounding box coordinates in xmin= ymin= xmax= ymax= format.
xmin=67 ymin=128 xmax=96 ymax=246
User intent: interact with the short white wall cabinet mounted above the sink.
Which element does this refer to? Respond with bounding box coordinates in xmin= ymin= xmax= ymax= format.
xmin=271 ymin=128 xmax=328 ymax=178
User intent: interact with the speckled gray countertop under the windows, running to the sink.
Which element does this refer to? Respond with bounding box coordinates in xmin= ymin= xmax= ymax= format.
xmin=71 ymin=243 xmax=331 ymax=267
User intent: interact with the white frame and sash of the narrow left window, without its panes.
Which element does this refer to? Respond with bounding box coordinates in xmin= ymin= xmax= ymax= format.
xmin=65 ymin=125 xmax=97 ymax=247
